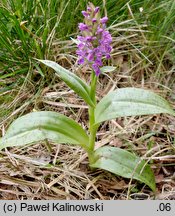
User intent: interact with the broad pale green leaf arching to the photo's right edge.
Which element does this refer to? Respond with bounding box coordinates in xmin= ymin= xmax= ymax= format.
xmin=95 ymin=88 xmax=175 ymax=124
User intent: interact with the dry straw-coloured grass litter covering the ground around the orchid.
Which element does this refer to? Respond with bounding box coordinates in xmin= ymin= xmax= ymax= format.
xmin=0 ymin=23 xmax=175 ymax=200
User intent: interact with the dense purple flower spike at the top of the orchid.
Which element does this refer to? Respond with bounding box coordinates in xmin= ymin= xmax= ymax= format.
xmin=76 ymin=3 xmax=112 ymax=76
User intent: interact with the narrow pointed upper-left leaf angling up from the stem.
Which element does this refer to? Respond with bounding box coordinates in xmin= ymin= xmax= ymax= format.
xmin=38 ymin=60 xmax=95 ymax=107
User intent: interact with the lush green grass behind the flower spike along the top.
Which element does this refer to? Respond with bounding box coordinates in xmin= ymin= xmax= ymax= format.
xmin=0 ymin=0 xmax=175 ymax=79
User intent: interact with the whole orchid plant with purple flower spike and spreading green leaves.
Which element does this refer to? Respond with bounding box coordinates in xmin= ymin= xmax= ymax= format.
xmin=0 ymin=3 xmax=175 ymax=191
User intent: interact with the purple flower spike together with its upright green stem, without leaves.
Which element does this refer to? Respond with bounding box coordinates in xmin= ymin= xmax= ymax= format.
xmin=77 ymin=3 xmax=112 ymax=163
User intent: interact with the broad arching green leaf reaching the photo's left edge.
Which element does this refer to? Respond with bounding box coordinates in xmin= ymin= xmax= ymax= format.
xmin=0 ymin=111 xmax=89 ymax=149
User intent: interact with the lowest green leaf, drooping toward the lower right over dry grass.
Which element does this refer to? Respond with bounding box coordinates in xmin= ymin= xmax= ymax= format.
xmin=90 ymin=147 xmax=156 ymax=191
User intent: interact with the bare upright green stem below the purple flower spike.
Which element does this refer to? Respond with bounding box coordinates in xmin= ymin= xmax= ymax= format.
xmin=88 ymin=72 xmax=98 ymax=162
